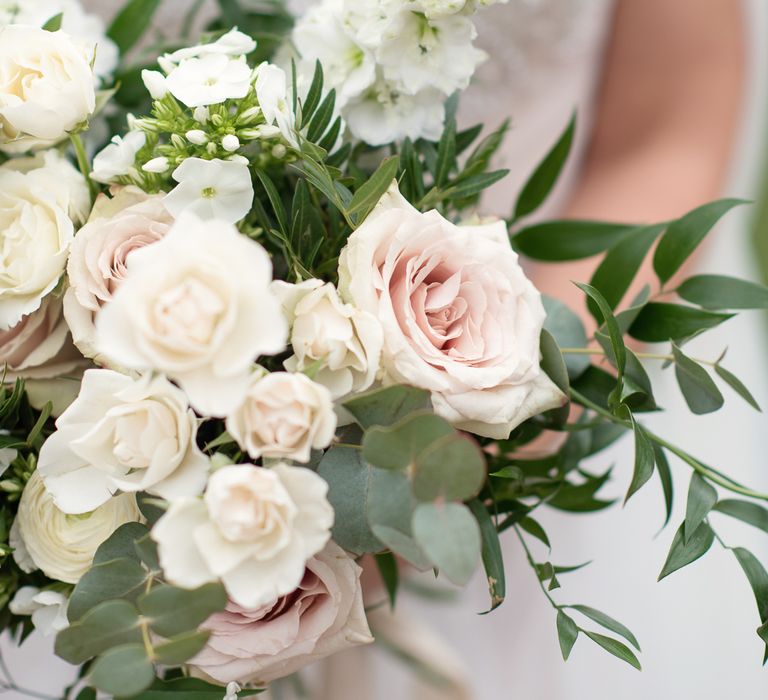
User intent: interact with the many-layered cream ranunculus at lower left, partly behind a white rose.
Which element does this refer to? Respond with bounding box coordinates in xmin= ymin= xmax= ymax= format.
xmin=10 ymin=471 xmax=141 ymax=583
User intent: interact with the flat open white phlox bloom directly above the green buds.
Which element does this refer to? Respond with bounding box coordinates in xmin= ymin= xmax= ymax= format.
xmin=165 ymin=53 xmax=251 ymax=107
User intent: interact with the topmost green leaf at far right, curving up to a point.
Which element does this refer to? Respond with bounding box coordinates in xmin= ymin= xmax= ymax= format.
xmin=653 ymin=199 xmax=745 ymax=283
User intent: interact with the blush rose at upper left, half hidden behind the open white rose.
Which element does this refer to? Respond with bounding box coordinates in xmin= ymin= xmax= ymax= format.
xmin=64 ymin=187 xmax=173 ymax=364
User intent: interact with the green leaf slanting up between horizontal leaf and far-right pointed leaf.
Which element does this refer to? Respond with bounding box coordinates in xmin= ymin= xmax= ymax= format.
xmin=587 ymin=224 xmax=664 ymax=321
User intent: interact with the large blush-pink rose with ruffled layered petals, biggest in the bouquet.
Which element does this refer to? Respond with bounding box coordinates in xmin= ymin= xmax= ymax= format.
xmin=339 ymin=183 xmax=565 ymax=438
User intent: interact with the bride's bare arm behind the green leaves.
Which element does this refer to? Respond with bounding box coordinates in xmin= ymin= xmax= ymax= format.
xmin=537 ymin=0 xmax=746 ymax=306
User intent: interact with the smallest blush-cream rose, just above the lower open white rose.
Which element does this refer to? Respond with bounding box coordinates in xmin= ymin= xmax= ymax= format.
xmin=227 ymin=372 xmax=336 ymax=462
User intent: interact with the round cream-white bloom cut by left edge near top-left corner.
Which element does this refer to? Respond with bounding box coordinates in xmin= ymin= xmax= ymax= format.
xmin=0 ymin=25 xmax=96 ymax=153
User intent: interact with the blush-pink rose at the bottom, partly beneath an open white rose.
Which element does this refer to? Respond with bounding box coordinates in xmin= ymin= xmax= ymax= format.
xmin=190 ymin=542 xmax=373 ymax=685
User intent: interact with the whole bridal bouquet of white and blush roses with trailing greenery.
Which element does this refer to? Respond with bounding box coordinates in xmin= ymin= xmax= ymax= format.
xmin=0 ymin=0 xmax=768 ymax=700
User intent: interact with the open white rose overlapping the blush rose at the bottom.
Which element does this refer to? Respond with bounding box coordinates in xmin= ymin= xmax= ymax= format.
xmin=152 ymin=464 xmax=333 ymax=608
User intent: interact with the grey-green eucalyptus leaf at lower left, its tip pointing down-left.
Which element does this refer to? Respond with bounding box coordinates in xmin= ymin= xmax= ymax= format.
xmin=67 ymin=559 xmax=147 ymax=622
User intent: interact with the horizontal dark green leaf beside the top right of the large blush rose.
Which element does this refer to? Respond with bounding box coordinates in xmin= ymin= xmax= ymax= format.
xmin=512 ymin=221 xmax=636 ymax=262
